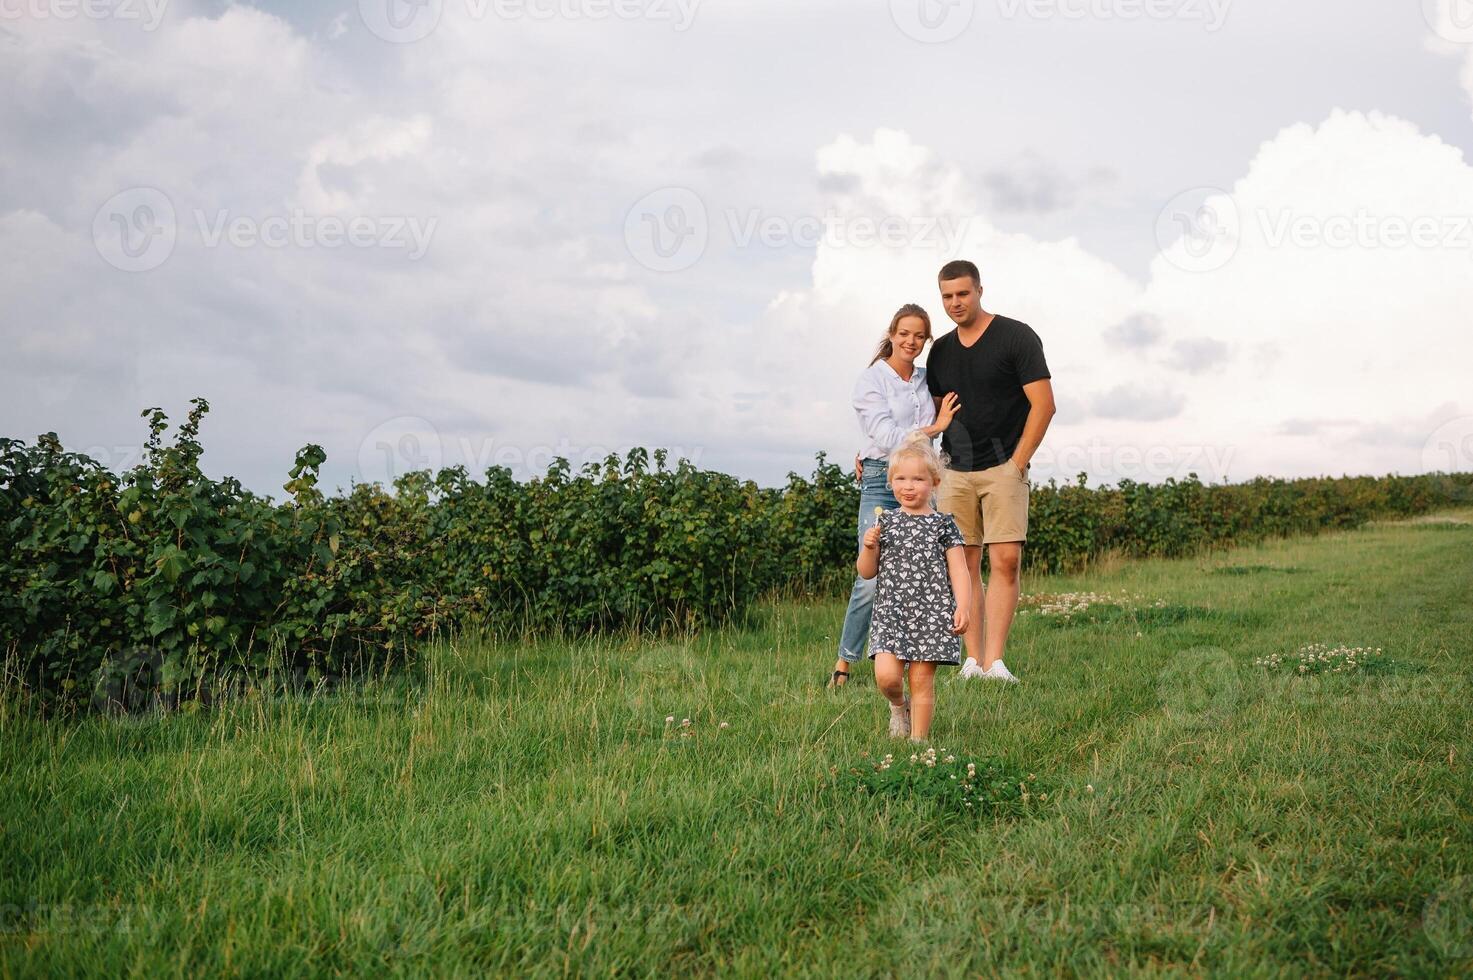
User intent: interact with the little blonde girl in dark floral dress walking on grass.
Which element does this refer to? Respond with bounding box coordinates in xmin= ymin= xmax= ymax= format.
xmin=854 ymin=432 xmax=971 ymax=741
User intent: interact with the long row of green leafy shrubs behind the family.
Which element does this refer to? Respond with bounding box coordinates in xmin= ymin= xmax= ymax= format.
xmin=0 ymin=399 xmax=1470 ymax=699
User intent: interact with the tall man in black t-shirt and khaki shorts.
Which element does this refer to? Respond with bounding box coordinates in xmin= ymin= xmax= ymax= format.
xmin=927 ymin=259 xmax=1055 ymax=684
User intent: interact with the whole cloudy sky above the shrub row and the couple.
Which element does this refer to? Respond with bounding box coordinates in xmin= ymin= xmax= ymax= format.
xmin=0 ymin=0 xmax=1473 ymax=497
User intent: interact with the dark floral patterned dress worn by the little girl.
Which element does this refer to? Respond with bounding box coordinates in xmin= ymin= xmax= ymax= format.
xmin=869 ymin=510 xmax=965 ymax=666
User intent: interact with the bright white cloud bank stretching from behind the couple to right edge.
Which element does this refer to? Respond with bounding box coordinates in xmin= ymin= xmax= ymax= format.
xmin=770 ymin=112 xmax=1473 ymax=479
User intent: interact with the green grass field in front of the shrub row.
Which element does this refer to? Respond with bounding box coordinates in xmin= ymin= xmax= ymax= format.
xmin=0 ymin=511 xmax=1473 ymax=976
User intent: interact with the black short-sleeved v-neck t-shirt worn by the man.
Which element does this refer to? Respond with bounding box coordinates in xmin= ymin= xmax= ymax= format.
xmin=925 ymin=315 xmax=1049 ymax=470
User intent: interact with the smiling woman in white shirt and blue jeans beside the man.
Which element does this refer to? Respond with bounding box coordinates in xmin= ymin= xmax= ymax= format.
xmin=829 ymin=304 xmax=960 ymax=687
